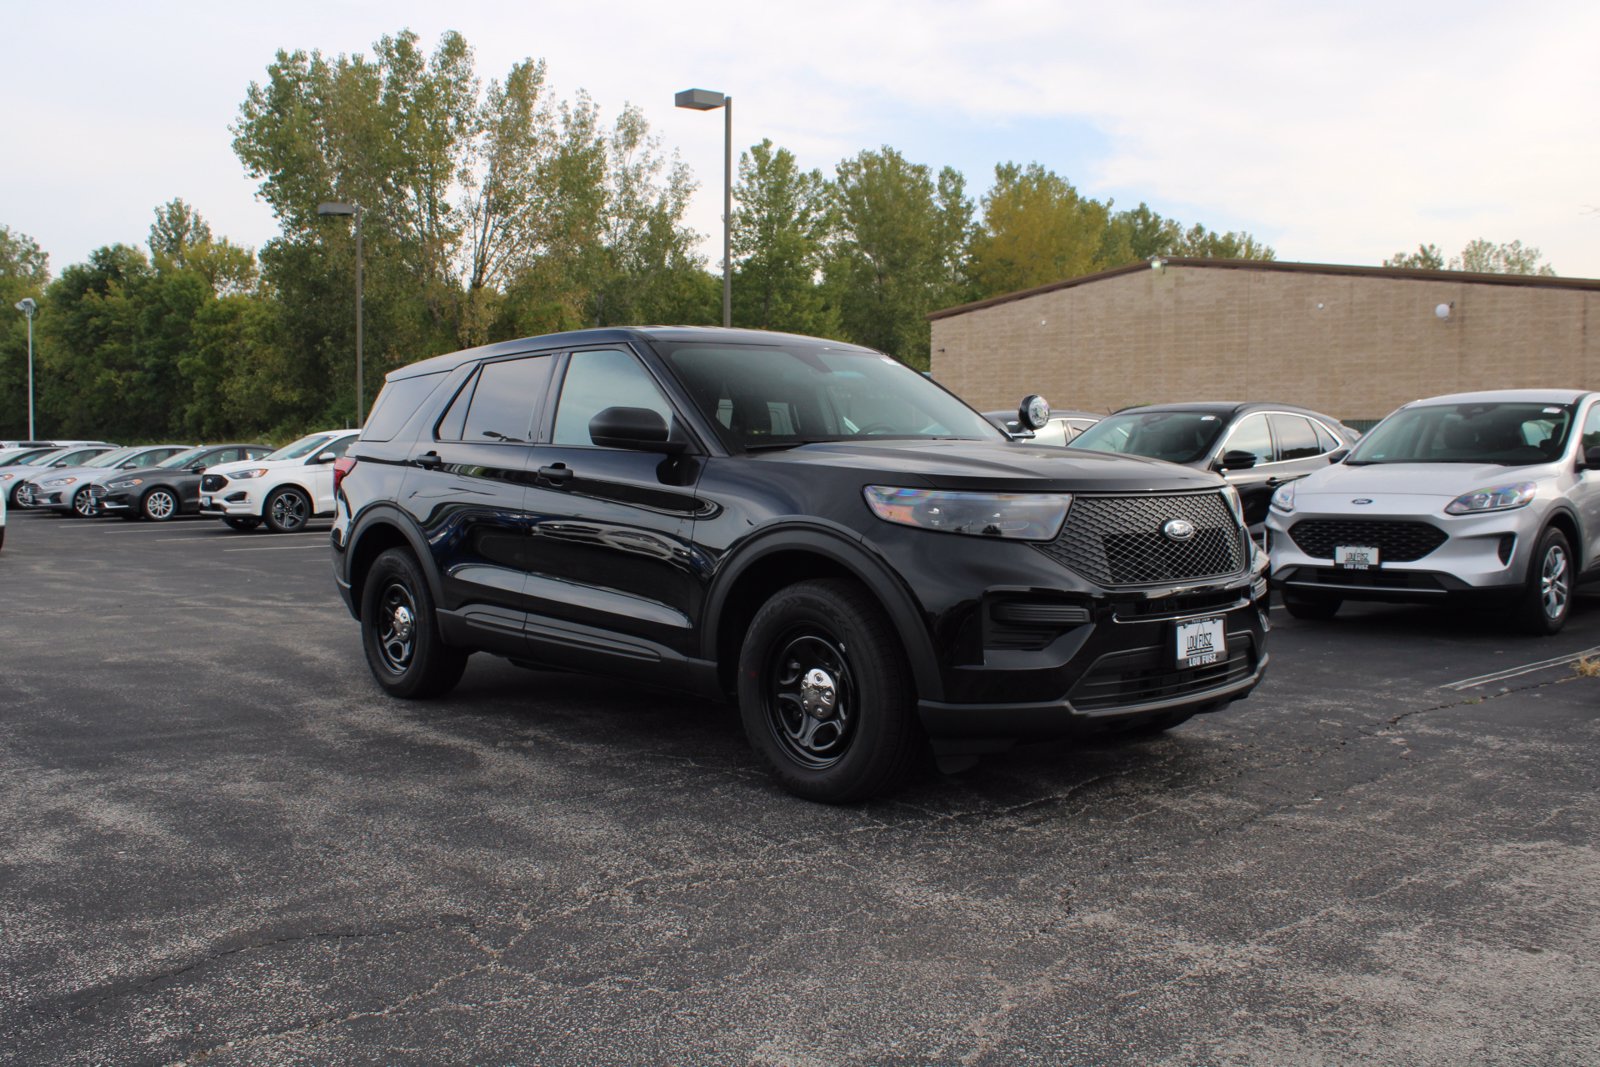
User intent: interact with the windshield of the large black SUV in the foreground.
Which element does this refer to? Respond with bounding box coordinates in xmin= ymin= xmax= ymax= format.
xmin=662 ymin=339 xmax=1005 ymax=450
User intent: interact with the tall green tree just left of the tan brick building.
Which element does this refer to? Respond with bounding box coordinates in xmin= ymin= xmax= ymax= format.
xmin=826 ymin=146 xmax=973 ymax=368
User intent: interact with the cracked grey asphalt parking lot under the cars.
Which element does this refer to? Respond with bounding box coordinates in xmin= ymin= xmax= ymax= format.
xmin=0 ymin=512 xmax=1600 ymax=1065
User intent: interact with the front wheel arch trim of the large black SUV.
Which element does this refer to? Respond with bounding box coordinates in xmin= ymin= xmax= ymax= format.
xmin=702 ymin=530 xmax=944 ymax=701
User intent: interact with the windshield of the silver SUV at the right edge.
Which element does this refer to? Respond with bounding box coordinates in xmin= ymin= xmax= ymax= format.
xmin=1346 ymin=402 xmax=1573 ymax=467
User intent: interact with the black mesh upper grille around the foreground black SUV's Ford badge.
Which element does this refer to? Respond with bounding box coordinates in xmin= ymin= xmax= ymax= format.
xmin=1038 ymin=491 xmax=1245 ymax=585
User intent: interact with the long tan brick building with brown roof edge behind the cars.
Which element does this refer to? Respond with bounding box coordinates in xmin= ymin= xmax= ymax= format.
xmin=930 ymin=258 xmax=1600 ymax=422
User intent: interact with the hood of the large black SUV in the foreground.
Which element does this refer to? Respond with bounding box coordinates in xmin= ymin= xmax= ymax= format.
xmin=752 ymin=438 xmax=1222 ymax=493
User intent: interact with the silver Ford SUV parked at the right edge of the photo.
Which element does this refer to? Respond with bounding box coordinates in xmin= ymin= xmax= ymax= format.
xmin=1267 ymin=389 xmax=1600 ymax=633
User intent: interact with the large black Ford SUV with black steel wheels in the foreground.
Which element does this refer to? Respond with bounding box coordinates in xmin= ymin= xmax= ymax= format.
xmin=333 ymin=326 xmax=1267 ymax=801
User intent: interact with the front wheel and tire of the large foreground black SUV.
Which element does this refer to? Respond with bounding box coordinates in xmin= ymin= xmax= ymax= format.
xmin=739 ymin=579 xmax=922 ymax=803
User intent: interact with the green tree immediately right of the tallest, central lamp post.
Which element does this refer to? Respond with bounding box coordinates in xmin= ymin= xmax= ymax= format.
xmin=730 ymin=139 xmax=838 ymax=334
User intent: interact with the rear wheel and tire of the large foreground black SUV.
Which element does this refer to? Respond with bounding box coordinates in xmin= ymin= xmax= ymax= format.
xmin=362 ymin=549 xmax=469 ymax=699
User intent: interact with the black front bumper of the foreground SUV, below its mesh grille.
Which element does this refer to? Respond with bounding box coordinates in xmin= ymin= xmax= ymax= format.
xmin=917 ymin=557 xmax=1270 ymax=755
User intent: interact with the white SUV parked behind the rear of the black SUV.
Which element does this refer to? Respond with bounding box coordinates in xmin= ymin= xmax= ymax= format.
xmin=200 ymin=430 xmax=362 ymax=533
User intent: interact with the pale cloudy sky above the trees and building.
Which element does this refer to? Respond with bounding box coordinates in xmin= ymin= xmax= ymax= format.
xmin=9 ymin=0 xmax=1600 ymax=278
